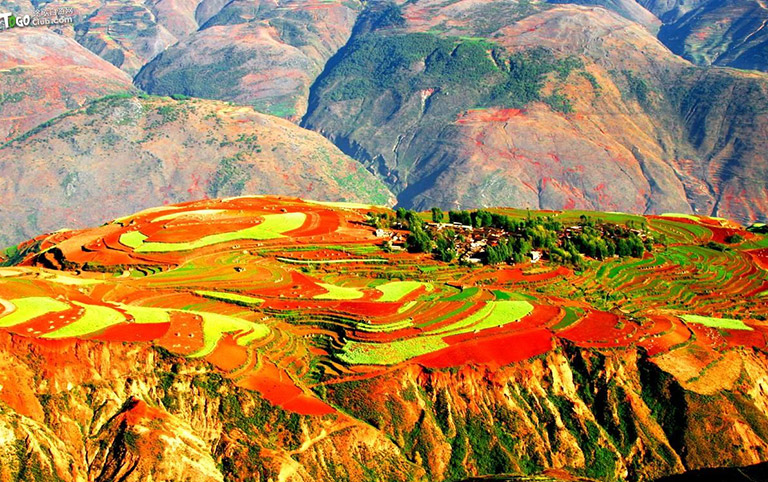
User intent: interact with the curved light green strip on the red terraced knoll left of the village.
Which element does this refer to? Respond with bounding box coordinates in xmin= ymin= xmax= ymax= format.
xmin=120 ymin=213 xmax=307 ymax=253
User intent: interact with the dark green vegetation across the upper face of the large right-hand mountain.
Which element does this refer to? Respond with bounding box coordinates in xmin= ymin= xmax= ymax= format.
xmin=318 ymin=33 xmax=584 ymax=115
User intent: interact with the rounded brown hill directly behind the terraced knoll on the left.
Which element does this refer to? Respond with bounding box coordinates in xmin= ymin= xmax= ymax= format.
xmin=0 ymin=96 xmax=391 ymax=245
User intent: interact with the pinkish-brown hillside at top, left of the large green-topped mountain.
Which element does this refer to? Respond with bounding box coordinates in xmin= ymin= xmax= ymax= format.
xmin=136 ymin=0 xmax=361 ymax=120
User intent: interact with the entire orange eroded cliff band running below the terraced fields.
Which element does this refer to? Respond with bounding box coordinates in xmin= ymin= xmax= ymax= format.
xmin=0 ymin=334 xmax=768 ymax=482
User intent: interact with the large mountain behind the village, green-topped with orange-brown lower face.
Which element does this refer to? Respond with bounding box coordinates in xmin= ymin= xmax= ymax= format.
xmin=303 ymin=0 xmax=768 ymax=222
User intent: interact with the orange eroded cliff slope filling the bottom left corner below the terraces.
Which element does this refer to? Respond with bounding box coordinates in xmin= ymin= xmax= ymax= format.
xmin=0 ymin=332 xmax=424 ymax=482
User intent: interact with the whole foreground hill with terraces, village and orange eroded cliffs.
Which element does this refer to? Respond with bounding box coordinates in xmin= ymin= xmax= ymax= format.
xmin=0 ymin=196 xmax=768 ymax=482
